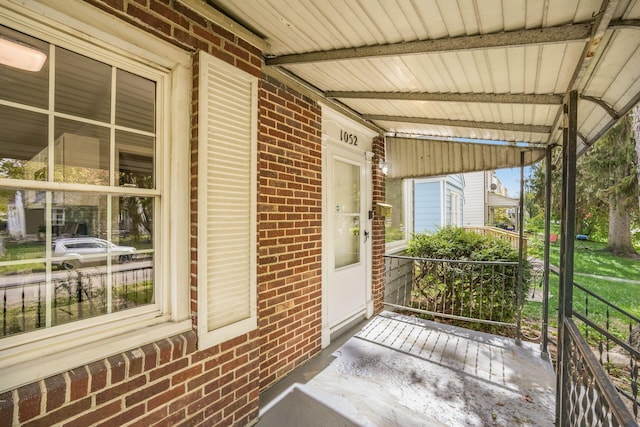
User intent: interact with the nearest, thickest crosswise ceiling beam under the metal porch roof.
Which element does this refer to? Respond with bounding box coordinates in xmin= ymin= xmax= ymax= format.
xmin=265 ymin=23 xmax=592 ymax=65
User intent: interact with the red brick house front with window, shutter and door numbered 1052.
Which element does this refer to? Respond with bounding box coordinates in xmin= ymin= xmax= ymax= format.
xmin=0 ymin=0 xmax=384 ymax=425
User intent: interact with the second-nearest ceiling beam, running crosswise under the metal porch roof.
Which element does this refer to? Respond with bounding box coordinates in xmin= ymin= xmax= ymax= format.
xmin=324 ymin=91 xmax=563 ymax=105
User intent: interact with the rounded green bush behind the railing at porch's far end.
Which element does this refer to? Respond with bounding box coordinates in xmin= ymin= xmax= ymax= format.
xmin=407 ymin=227 xmax=531 ymax=323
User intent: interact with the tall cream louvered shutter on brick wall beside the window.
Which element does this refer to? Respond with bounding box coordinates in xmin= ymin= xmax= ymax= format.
xmin=198 ymin=52 xmax=258 ymax=348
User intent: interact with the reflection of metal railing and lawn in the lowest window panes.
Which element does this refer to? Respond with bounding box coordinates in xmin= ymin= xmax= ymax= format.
xmin=0 ymin=266 xmax=153 ymax=338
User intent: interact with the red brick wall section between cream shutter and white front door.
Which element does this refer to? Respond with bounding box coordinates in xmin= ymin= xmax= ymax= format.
xmin=258 ymin=76 xmax=322 ymax=387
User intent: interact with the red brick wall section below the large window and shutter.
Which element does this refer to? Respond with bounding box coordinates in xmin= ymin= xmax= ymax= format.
xmin=0 ymin=332 xmax=259 ymax=427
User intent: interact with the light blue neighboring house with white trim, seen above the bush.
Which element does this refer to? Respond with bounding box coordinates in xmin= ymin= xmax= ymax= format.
xmin=413 ymin=174 xmax=466 ymax=233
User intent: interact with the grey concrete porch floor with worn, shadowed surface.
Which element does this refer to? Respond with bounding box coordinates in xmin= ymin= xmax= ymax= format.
xmin=257 ymin=311 xmax=555 ymax=427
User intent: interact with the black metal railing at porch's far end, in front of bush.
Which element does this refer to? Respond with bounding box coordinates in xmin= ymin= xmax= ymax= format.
xmin=384 ymin=255 xmax=523 ymax=339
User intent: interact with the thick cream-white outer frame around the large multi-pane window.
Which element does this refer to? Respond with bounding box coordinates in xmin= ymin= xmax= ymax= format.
xmin=0 ymin=0 xmax=192 ymax=392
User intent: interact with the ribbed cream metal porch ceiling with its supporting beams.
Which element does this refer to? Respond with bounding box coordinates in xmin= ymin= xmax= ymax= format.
xmin=202 ymin=0 xmax=640 ymax=175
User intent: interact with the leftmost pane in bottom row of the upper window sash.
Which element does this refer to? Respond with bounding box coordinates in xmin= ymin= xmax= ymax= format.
xmin=0 ymin=106 xmax=47 ymax=181
